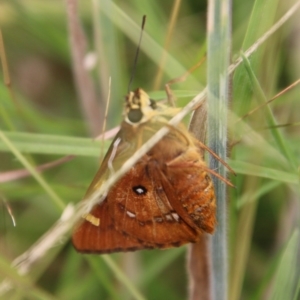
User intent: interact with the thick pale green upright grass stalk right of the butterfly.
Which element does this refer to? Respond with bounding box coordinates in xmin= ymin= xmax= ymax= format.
xmin=207 ymin=0 xmax=231 ymax=300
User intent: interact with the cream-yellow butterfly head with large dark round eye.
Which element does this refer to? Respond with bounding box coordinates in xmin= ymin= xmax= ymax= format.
xmin=125 ymin=89 xmax=157 ymax=125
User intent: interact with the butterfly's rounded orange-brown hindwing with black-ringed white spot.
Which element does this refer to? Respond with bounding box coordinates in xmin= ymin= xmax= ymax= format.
xmin=107 ymin=156 xmax=199 ymax=249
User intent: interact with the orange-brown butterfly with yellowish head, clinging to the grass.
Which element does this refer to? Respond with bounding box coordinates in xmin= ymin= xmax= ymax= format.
xmin=72 ymin=88 xmax=223 ymax=254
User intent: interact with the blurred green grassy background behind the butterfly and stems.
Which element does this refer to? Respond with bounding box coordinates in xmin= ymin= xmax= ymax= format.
xmin=0 ymin=0 xmax=300 ymax=300
